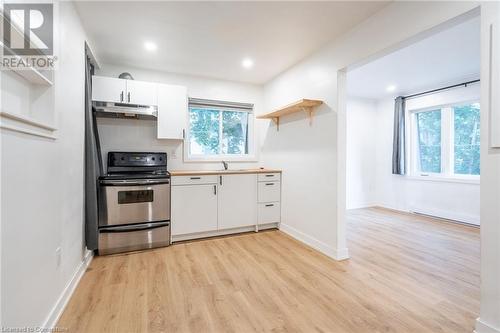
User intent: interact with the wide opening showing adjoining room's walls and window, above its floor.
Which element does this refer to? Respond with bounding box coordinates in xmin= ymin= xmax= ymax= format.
xmin=346 ymin=16 xmax=480 ymax=226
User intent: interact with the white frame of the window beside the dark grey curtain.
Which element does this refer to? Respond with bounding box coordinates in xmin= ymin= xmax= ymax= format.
xmin=406 ymin=98 xmax=481 ymax=184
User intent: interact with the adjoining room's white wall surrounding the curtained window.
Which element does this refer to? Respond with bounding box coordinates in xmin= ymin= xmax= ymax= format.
xmin=375 ymin=85 xmax=480 ymax=224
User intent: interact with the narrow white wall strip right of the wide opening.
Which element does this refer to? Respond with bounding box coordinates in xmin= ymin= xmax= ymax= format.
xmin=476 ymin=2 xmax=500 ymax=333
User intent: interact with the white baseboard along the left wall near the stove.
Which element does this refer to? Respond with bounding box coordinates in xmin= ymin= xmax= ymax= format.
xmin=42 ymin=250 xmax=94 ymax=328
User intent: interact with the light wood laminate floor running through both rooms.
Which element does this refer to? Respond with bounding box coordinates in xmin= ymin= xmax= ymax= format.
xmin=58 ymin=209 xmax=479 ymax=333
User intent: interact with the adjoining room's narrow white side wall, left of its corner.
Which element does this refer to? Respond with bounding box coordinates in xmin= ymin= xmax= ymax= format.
xmin=346 ymin=98 xmax=377 ymax=209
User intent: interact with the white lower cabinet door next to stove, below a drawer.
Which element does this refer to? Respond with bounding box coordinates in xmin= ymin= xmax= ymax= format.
xmin=171 ymin=184 xmax=217 ymax=236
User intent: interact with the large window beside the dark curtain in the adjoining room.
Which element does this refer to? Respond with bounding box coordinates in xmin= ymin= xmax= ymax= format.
xmin=410 ymin=103 xmax=480 ymax=178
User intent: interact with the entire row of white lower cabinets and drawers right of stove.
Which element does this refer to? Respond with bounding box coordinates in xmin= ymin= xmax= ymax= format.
xmin=171 ymin=173 xmax=281 ymax=240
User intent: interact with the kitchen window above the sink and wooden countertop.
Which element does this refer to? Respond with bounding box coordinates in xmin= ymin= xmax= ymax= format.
xmin=186 ymin=100 xmax=253 ymax=160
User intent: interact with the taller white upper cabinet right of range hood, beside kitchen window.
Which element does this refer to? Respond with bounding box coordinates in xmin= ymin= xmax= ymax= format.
xmin=158 ymin=84 xmax=188 ymax=139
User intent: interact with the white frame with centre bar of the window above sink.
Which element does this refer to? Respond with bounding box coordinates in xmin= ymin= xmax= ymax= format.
xmin=183 ymin=102 xmax=257 ymax=163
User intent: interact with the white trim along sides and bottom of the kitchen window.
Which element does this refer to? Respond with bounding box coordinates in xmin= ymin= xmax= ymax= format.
xmin=183 ymin=104 xmax=258 ymax=163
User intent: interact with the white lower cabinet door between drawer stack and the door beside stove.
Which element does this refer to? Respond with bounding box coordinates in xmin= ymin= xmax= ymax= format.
xmin=219 ymin=174 xmax=257 ymax=230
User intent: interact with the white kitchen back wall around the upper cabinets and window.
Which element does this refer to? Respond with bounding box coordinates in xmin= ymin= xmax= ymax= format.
xmin=96 ymin=64 xmax=263 ymax=170
